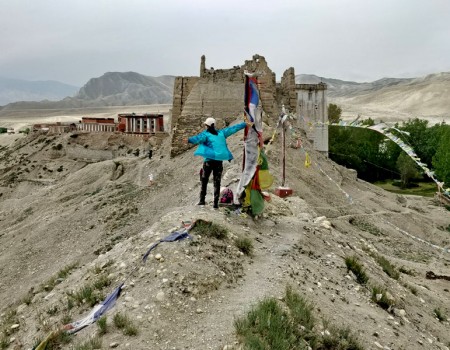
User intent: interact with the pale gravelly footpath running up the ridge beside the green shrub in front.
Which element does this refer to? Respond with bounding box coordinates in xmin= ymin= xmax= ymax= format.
xmin=172 ymin=217 xmax=302 ymax=349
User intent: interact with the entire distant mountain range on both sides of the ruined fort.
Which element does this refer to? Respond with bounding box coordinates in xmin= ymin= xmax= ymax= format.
xmin=0 ymin=72 xmax=450 ymax=122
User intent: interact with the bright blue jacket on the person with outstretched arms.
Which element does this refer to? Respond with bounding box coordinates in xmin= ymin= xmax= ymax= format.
xmin=188 ymin=122 xmax=246 ymax=161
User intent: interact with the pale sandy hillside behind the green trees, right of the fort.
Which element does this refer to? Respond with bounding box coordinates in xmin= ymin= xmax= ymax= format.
xmin=296 ymin=72 xmax=450 ymax=124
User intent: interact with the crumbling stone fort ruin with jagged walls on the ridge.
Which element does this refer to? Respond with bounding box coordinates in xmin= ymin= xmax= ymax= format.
xmin=171 ymin=55 xmax=326 ymax=157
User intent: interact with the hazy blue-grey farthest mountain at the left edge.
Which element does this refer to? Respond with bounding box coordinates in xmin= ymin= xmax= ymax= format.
xmin=0 ymin=77 xmax=79 ymax=106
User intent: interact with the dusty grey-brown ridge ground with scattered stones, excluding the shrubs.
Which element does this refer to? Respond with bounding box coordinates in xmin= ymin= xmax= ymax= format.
xmin=0 ymin=107 xmax=450 ymax=349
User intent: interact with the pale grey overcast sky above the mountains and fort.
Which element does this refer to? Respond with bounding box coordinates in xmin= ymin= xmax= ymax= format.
xmin=0 ymin=0 xmax=450 ymax=86
